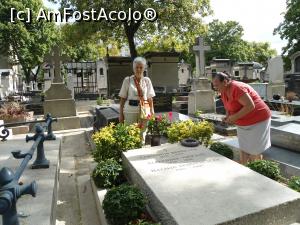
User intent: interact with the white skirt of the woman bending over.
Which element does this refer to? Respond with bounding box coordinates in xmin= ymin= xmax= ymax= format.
xmin=237 ymin=118 xmax=271 ymax=155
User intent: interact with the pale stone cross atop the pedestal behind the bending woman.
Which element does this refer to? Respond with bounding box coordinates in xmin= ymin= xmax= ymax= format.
xmin=193 ymin=37 xmax=210 ymax=77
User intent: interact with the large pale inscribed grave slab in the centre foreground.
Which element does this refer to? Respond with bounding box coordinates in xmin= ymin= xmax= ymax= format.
xmin=123 ymin=144 xmax=300 ymax=225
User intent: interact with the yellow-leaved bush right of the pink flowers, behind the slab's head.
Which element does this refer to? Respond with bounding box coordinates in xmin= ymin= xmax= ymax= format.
xmin=167 ymin=120 xmax=214 ymax=146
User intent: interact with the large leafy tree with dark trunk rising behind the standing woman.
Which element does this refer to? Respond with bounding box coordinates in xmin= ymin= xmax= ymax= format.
xmin=52 ymin=0 xmax=210 ymax=58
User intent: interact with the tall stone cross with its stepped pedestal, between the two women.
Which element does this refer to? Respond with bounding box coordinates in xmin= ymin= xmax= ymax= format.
xmin=188 ymin=37 xmax=216 ymax=115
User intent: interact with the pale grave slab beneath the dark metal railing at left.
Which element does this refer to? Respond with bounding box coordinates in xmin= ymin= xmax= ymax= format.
xmin=0 ymin=134 xmax=61 ymax=225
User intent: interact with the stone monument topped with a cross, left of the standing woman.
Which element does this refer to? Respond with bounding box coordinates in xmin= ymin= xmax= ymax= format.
xmin=44 ymin=46 xmax=80 ymax=130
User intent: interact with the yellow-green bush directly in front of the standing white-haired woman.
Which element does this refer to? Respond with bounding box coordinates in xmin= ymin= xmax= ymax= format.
xmin=92 ymin=123 xmax=142 ymax=162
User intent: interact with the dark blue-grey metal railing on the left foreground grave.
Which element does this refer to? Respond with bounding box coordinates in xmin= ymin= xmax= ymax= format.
xmin=0 ymin=114 xmax=57 ymax=225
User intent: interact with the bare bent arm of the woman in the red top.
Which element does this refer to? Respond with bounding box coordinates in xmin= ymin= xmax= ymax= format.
xmin=225 ymin=93 xmax=255 ymax=124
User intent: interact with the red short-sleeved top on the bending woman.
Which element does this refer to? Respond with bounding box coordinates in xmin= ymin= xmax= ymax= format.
xmin=221 ymin=81 xmax=271 ymax=126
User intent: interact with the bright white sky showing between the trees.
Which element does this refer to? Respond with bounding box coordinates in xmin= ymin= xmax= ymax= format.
xmin=43 ymin=0 xmax=287 ymax=55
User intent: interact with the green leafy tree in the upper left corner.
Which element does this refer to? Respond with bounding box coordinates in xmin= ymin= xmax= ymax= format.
xmin=0 ymin=0 xmax=57 ymax=83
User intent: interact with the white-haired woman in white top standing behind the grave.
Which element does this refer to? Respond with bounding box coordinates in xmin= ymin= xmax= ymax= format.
xmin=119 ymin=57 xmax=155 ymax=124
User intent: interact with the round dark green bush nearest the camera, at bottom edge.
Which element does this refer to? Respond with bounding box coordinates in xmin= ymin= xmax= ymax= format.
xmin=103 ymin=184 xmax=146 ymax=225
